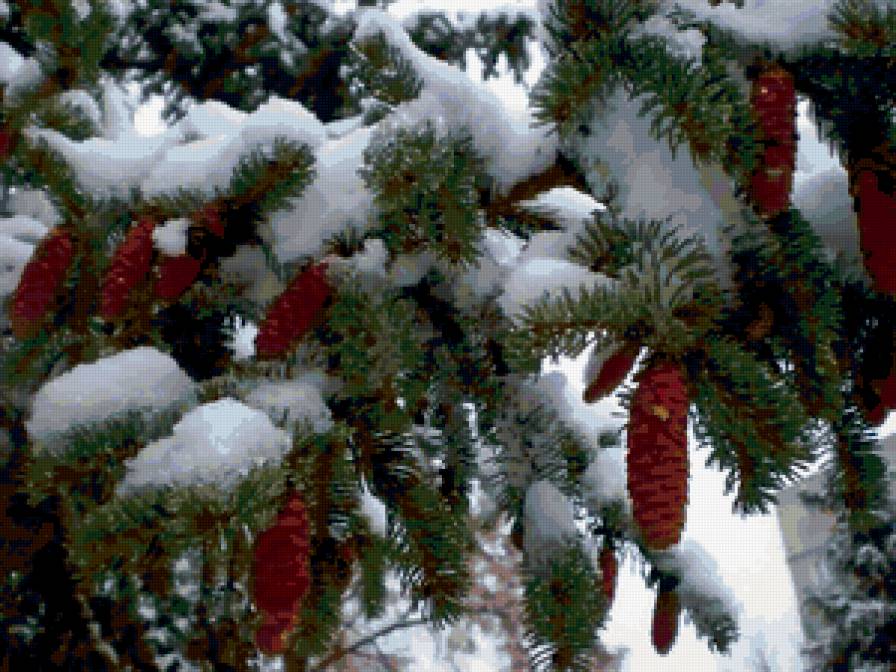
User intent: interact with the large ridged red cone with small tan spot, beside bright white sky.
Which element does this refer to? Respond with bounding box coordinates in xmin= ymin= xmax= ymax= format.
xmin=626 ymin=362 xmax=688 ymax=550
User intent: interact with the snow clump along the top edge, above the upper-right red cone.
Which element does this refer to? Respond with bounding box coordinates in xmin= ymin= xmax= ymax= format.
xmin=666 ymin=0 xmax=852 ymax=51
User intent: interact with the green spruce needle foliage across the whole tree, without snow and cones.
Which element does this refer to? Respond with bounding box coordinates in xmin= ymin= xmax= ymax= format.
xmin=0 ymin=0 xmax=896 ymax=670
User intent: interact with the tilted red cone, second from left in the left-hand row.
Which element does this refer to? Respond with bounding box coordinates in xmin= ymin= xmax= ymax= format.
xmin=100 ymin=218 xmax=155 ymax=320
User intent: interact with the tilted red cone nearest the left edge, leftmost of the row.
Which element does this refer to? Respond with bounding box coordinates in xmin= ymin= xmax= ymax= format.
xmin=9 ymin=228 xmax=74 ymax=338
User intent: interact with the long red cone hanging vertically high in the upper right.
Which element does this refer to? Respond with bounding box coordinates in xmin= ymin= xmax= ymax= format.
xmin=750 ymin=65 xmax=797 ymax=217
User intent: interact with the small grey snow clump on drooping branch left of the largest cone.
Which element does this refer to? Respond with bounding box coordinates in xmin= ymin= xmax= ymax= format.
xmin=523 ymin=481 xmax=578 ymax=568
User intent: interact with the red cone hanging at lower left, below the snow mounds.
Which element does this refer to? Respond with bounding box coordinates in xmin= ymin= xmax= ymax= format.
xmin=252 ymin=494 xmax=311 ymax=654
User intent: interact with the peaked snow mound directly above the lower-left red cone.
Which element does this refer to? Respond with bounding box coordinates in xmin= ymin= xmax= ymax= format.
xmin=117 ymin=397 xmax=290 ymax=494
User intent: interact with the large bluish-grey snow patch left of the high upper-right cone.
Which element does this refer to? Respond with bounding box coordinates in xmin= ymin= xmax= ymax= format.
xmin=570 ymin=88 xmax=736 ymax=286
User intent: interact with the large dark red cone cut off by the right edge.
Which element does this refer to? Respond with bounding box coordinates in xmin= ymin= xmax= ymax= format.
xmin=855 ymin=169 xmax=896 ymax=295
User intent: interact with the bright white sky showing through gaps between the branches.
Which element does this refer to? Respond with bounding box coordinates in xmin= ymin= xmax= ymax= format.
xmin=128 ymin=0 xmax=896 ymax=672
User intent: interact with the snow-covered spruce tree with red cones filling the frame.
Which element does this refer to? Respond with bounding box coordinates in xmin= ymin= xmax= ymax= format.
xmin=0 ymin=0 xmax=896 ymax=672
